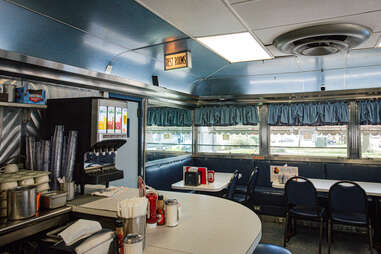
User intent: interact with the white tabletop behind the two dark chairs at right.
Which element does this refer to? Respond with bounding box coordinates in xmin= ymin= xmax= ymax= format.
xmin=273 ymin=178 xmax=381 ymax=197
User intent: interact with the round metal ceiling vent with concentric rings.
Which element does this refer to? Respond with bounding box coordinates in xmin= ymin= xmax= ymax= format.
xmin=273 ymin=24 xmax=371 ymax=56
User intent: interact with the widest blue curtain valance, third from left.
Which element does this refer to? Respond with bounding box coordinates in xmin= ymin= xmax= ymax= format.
xmin=268 ymin=102 xmax=349 ymax=126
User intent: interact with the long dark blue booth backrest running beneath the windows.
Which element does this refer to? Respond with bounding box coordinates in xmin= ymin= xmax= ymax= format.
xmin=146 ymin=157 xmax=381 ymax=190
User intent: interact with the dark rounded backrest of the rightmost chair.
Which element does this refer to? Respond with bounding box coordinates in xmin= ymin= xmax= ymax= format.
xmin=328 ymin=181 xmax=368 ymax=215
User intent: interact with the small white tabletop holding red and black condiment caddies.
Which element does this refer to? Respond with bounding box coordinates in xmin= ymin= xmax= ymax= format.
xmin=171 ymin=172 xmax=233 ymax=192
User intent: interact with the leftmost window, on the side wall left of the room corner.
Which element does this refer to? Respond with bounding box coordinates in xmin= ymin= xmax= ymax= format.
xmin=146 ymin=126 xmax=192 ymax=153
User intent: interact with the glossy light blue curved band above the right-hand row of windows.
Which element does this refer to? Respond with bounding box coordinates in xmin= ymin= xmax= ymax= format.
xmin=192 ymin=66 xmax=381 ymax=96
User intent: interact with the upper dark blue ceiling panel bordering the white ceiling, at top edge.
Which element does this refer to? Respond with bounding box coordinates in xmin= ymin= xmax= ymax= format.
xmin=8 ymin=0 xmax=187 ymax=49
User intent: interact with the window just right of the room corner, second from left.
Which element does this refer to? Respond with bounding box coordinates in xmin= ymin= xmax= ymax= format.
xmin=198 ymin=125 xmax=259 ymax=154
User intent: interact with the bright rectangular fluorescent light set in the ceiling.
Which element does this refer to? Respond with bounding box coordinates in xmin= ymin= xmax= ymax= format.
xmin=197 ymin=32 xmax=272 ymax=63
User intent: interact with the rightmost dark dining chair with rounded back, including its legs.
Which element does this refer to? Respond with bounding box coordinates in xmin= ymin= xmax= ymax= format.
xmin=328 ymin=181 xmax=373 ymax=254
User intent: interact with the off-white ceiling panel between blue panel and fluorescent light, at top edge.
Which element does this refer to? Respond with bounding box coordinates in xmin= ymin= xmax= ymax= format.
xmin=136 ymin=0 xmax=245 ymax=37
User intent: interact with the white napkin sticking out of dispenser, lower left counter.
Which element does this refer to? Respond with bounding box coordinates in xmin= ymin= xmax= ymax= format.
xmin=58 ymin=219 xmax=102 ymax=246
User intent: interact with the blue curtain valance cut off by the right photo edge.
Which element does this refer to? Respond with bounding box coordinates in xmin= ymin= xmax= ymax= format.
xmin=358 ymin=100 xmax=381 ymax=124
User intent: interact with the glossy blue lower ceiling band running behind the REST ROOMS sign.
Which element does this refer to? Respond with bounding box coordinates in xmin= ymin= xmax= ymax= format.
xmin=0 ymin=1 xmax=227 ymax=93
